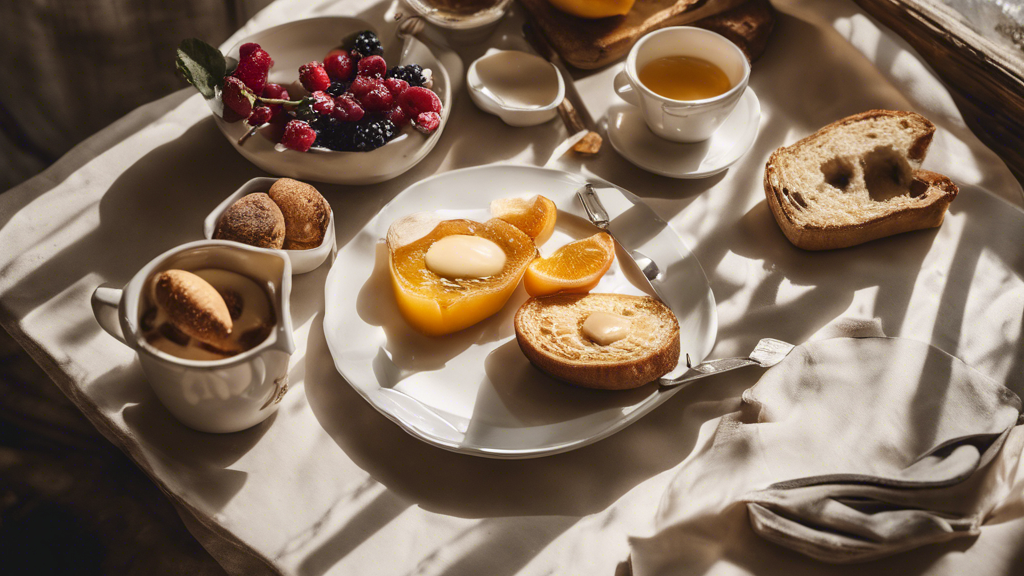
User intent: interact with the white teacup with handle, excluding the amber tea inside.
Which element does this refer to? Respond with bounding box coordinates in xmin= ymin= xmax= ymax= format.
xmin=614 ymin=26 xmax=751 ymax=142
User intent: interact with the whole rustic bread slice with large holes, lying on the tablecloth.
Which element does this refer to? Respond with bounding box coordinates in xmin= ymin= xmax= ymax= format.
xmin=764 ymin=110 xmax=958 ymax=250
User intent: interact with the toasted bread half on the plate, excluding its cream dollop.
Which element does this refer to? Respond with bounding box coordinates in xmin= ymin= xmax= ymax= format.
xmin=515 ymin=294 xmax=679 ymax=389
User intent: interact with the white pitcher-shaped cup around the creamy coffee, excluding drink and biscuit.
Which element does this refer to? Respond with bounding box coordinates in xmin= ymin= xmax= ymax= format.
xmin=92 ymin=240 xmax=295 ymax=433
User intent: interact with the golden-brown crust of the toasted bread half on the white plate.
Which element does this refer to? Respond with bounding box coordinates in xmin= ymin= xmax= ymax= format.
xmin=514 ymin=294 xmax=680 ymax=389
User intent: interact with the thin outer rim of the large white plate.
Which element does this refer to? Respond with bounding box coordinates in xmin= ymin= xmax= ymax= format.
xmin=323 ymin=163 xmax=718 ymax=460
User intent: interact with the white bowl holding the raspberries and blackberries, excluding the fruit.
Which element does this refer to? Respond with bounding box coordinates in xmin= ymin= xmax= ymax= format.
xmin=206 ymin=16 xmax=452 ymax=184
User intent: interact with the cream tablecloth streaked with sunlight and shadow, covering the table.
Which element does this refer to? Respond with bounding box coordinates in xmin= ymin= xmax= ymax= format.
xmin=0 ymin=0 xmax=1024 ymax=576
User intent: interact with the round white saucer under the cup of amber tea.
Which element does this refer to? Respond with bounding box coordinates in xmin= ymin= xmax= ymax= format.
xmin=608 ymin=87 xmax=761 ymax=178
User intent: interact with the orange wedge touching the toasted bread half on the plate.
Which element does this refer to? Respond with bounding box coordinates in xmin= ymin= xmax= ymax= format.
xmin=523 ymin=232 xmax=615 ymax=296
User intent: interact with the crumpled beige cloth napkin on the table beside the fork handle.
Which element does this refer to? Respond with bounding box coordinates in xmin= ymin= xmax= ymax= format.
xmin=631 ymin=322 xmax=1021 ymax=575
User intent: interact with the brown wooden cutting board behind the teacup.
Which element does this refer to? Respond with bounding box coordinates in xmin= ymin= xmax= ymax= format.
xmin=519 ymin=0 xmax=775 ymax=70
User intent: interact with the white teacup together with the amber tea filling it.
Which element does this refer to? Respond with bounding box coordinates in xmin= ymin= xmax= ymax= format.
xmin=614 ymin=27 xmax=751 ymax=142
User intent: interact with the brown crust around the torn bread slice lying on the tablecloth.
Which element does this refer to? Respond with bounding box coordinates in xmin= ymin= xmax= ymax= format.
xmin=764 ymin=110 xmax=959 ymax=250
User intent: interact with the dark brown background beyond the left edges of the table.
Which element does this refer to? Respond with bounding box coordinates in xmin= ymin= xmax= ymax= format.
xmin=0 ymin=0 xmax=270 ymax=575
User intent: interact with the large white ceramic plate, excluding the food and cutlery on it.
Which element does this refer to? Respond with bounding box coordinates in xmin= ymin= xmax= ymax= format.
xmin=324 ymin=165 xmax=718 ymax=458
